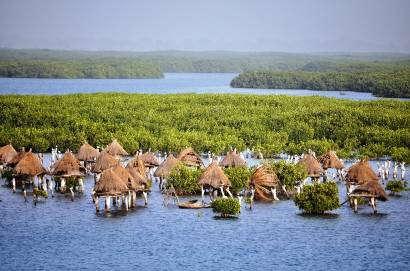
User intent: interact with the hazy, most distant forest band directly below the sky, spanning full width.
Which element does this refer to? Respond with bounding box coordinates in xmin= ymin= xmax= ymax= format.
xmin=0 ymin=49 xmax=410 ymax=72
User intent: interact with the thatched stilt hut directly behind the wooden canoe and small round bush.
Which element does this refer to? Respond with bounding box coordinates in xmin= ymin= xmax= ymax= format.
xmin=198 ymin=161 xmax=233 ymax=201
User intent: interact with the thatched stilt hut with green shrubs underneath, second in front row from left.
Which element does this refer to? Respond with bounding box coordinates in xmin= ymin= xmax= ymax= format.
xmin=51 ymin=150 xmax=85 ymax=200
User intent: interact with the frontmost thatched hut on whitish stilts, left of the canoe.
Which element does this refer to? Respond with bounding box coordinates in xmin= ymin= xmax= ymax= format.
xmin=94 ymin=168 xmax=129 ymax=215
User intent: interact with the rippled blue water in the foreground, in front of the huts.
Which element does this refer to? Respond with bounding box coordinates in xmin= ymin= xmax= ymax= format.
xmin=0 ymin=156 xmax=410 ymax=270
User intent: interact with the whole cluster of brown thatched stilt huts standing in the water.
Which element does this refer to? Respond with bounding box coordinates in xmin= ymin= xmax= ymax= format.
xmin=0 ymin=140 xmax=387 ymax=215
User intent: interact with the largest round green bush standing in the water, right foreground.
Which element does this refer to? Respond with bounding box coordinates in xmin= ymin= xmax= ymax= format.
xmin=294 ymin=182 xmax=340 ymax=214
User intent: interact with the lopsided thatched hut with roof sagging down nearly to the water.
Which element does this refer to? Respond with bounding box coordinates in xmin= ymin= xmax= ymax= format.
xmin=249 ymin=165 xmax=280 ymax=201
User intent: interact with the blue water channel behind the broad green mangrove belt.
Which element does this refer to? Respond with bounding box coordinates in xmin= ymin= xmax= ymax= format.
xmin=0 ymin=73 xmax=377 ymax=100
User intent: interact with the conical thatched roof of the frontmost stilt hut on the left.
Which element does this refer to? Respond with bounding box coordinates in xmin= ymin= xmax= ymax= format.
xmin=94 ymin=169 xmax=128 ymax=196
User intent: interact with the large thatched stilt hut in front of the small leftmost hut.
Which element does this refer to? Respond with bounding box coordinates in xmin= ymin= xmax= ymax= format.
xmin=13 ymin=150 xmax=47 ymax=203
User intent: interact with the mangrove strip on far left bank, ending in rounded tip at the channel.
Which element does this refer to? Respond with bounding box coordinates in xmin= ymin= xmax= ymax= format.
xmin=0 ymin=59 xmax=163 ymax=78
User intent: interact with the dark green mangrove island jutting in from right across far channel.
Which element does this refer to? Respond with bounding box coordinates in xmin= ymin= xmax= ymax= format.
xmin=231 ymin=71 xmax=410 ymax=98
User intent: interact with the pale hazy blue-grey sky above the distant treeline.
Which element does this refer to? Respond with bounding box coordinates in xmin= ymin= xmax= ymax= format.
xmin=0 ymin=0 xmax=410 ymax=52
